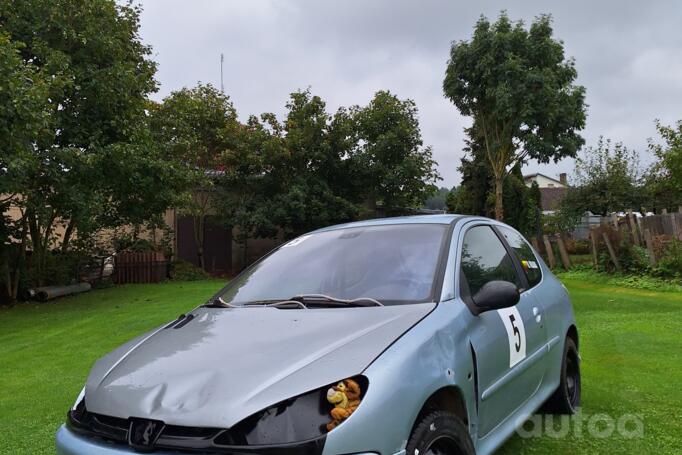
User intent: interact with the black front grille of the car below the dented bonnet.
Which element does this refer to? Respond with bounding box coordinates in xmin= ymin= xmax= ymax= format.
xmin=67 ymin=401 xmax=325 ymax=455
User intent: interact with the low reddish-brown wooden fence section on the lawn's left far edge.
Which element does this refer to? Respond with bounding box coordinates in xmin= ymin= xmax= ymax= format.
xmin=114 ymin=251 xmax=168 ymax=284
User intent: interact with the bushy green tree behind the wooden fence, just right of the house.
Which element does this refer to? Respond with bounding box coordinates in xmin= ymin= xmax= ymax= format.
xmin=560 ymin=138 xmax=642 ymax=220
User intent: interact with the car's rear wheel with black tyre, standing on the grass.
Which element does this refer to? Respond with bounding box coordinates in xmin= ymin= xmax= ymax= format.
xmin=543 ymin=338 xmax=581 ymax=415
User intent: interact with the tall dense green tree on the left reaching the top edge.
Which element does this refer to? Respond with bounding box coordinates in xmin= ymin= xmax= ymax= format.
xmin=0 ymin=0 xmax=186 ymax=290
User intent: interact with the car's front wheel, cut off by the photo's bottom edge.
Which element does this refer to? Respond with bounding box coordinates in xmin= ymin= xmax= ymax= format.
xmin=406 ymin=411 xmax=476 ymax=455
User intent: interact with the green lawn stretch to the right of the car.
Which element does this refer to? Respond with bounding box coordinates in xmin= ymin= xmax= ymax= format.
xmin=499 ymin=274 xmax=682 ymax=454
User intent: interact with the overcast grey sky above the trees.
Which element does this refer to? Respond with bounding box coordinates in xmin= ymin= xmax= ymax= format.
xmin=134 ymin=0 xmax=682 ymax=186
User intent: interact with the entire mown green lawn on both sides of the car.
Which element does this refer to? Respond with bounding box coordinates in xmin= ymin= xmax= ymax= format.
xmin=0 ymin=278 xmax=682 ymax=455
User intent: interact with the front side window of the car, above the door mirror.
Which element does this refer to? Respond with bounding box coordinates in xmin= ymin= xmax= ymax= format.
xmin=461 ymin=226 xmax=522 ymax=296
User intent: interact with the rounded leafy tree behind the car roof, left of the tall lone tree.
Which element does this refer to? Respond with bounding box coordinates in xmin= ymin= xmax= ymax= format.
xmin=351 ymin=91 xmax=441 ymax=216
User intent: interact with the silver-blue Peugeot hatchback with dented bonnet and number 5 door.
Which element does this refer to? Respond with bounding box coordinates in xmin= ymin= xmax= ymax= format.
xmin=57 ymin=215 xmax=580 ymax=455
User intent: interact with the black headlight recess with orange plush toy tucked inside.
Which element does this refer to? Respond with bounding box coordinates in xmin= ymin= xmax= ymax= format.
xmin=215 ymin=376 xmax=368 ymax=446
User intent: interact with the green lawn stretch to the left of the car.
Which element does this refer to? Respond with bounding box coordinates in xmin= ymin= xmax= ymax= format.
xmin=0 ymin=281 xmax=222 ymax=455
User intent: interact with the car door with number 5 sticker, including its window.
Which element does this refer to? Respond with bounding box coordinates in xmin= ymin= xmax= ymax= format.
xmin=459 ymin=224 xmax=546 ymax=437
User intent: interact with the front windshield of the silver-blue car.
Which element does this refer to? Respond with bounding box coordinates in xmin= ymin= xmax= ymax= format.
xmin=220 ymin=224 xmax=447 ymax=305
